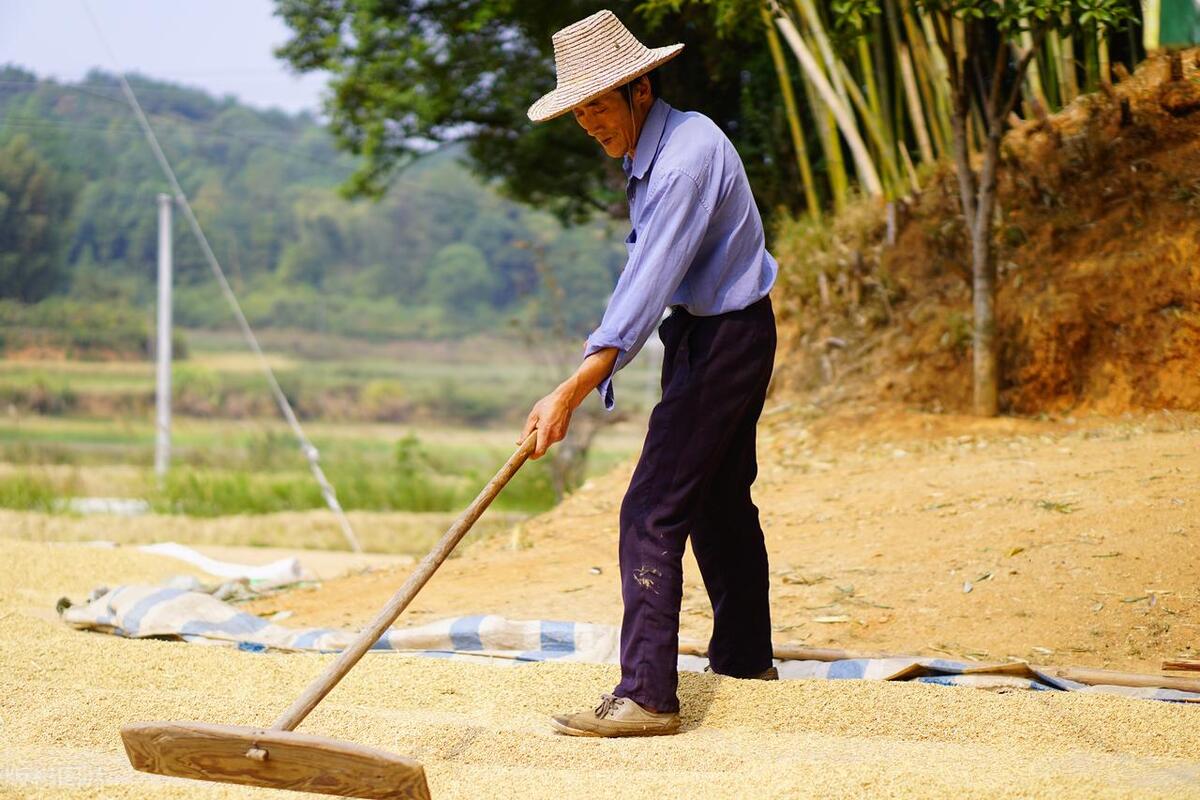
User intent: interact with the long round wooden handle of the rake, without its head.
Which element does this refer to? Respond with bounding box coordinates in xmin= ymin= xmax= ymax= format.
xmin=271 ymin=431 xmax=538 ymax=730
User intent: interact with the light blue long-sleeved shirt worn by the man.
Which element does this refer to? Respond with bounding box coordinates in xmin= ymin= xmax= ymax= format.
xmin=583 ymin=100 xmax=779 ymax=409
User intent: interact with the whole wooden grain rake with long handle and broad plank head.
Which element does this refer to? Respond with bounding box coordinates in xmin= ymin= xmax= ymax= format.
xmin=121 ymin=431 xmax=538 ymax=800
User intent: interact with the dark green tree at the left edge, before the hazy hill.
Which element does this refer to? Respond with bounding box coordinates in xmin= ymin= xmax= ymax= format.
xmin=0 ymin=136 xmax=72 ymax=302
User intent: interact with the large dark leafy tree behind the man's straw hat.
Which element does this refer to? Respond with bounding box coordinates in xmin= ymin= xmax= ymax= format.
xmin=276 ymin=0 xmax=799 ymax=221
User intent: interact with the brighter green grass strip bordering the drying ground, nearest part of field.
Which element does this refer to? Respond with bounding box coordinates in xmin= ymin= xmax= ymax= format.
xmin=0 ymin=417 xmax=619 ymax=517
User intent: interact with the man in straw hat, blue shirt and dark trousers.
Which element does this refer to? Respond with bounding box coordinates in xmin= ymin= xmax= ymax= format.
xmin=521 ymin=11 xmax=778 ymax=736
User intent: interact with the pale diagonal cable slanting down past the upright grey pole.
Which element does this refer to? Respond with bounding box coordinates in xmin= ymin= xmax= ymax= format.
xmin=79 ymin=0 xmax=362 ymax=553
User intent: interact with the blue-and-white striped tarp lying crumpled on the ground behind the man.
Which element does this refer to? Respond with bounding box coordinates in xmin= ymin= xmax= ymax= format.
xmin=62 ymin=585 xmax=1200 ymax=702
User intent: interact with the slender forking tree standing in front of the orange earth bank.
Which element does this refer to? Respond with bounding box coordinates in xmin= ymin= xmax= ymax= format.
xmin=917 ymin=0 xmax=1134 ymax=416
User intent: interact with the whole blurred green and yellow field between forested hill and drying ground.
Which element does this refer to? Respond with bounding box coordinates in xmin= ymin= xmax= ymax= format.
xmin=0 ymin=333 xmax=654 ymax=537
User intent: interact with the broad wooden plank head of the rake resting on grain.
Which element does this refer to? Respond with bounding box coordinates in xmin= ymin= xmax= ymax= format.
xmin=121 ymin=722 xmax=430 ymax=800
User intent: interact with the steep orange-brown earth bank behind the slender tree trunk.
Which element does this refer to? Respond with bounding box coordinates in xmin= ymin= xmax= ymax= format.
xmin=776 ymin=50 xmax=1200 ymax=415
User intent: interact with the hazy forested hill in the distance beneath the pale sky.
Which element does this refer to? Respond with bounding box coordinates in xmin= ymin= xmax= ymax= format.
xmin=0 ymin=66 xmax=624 ymax=338
